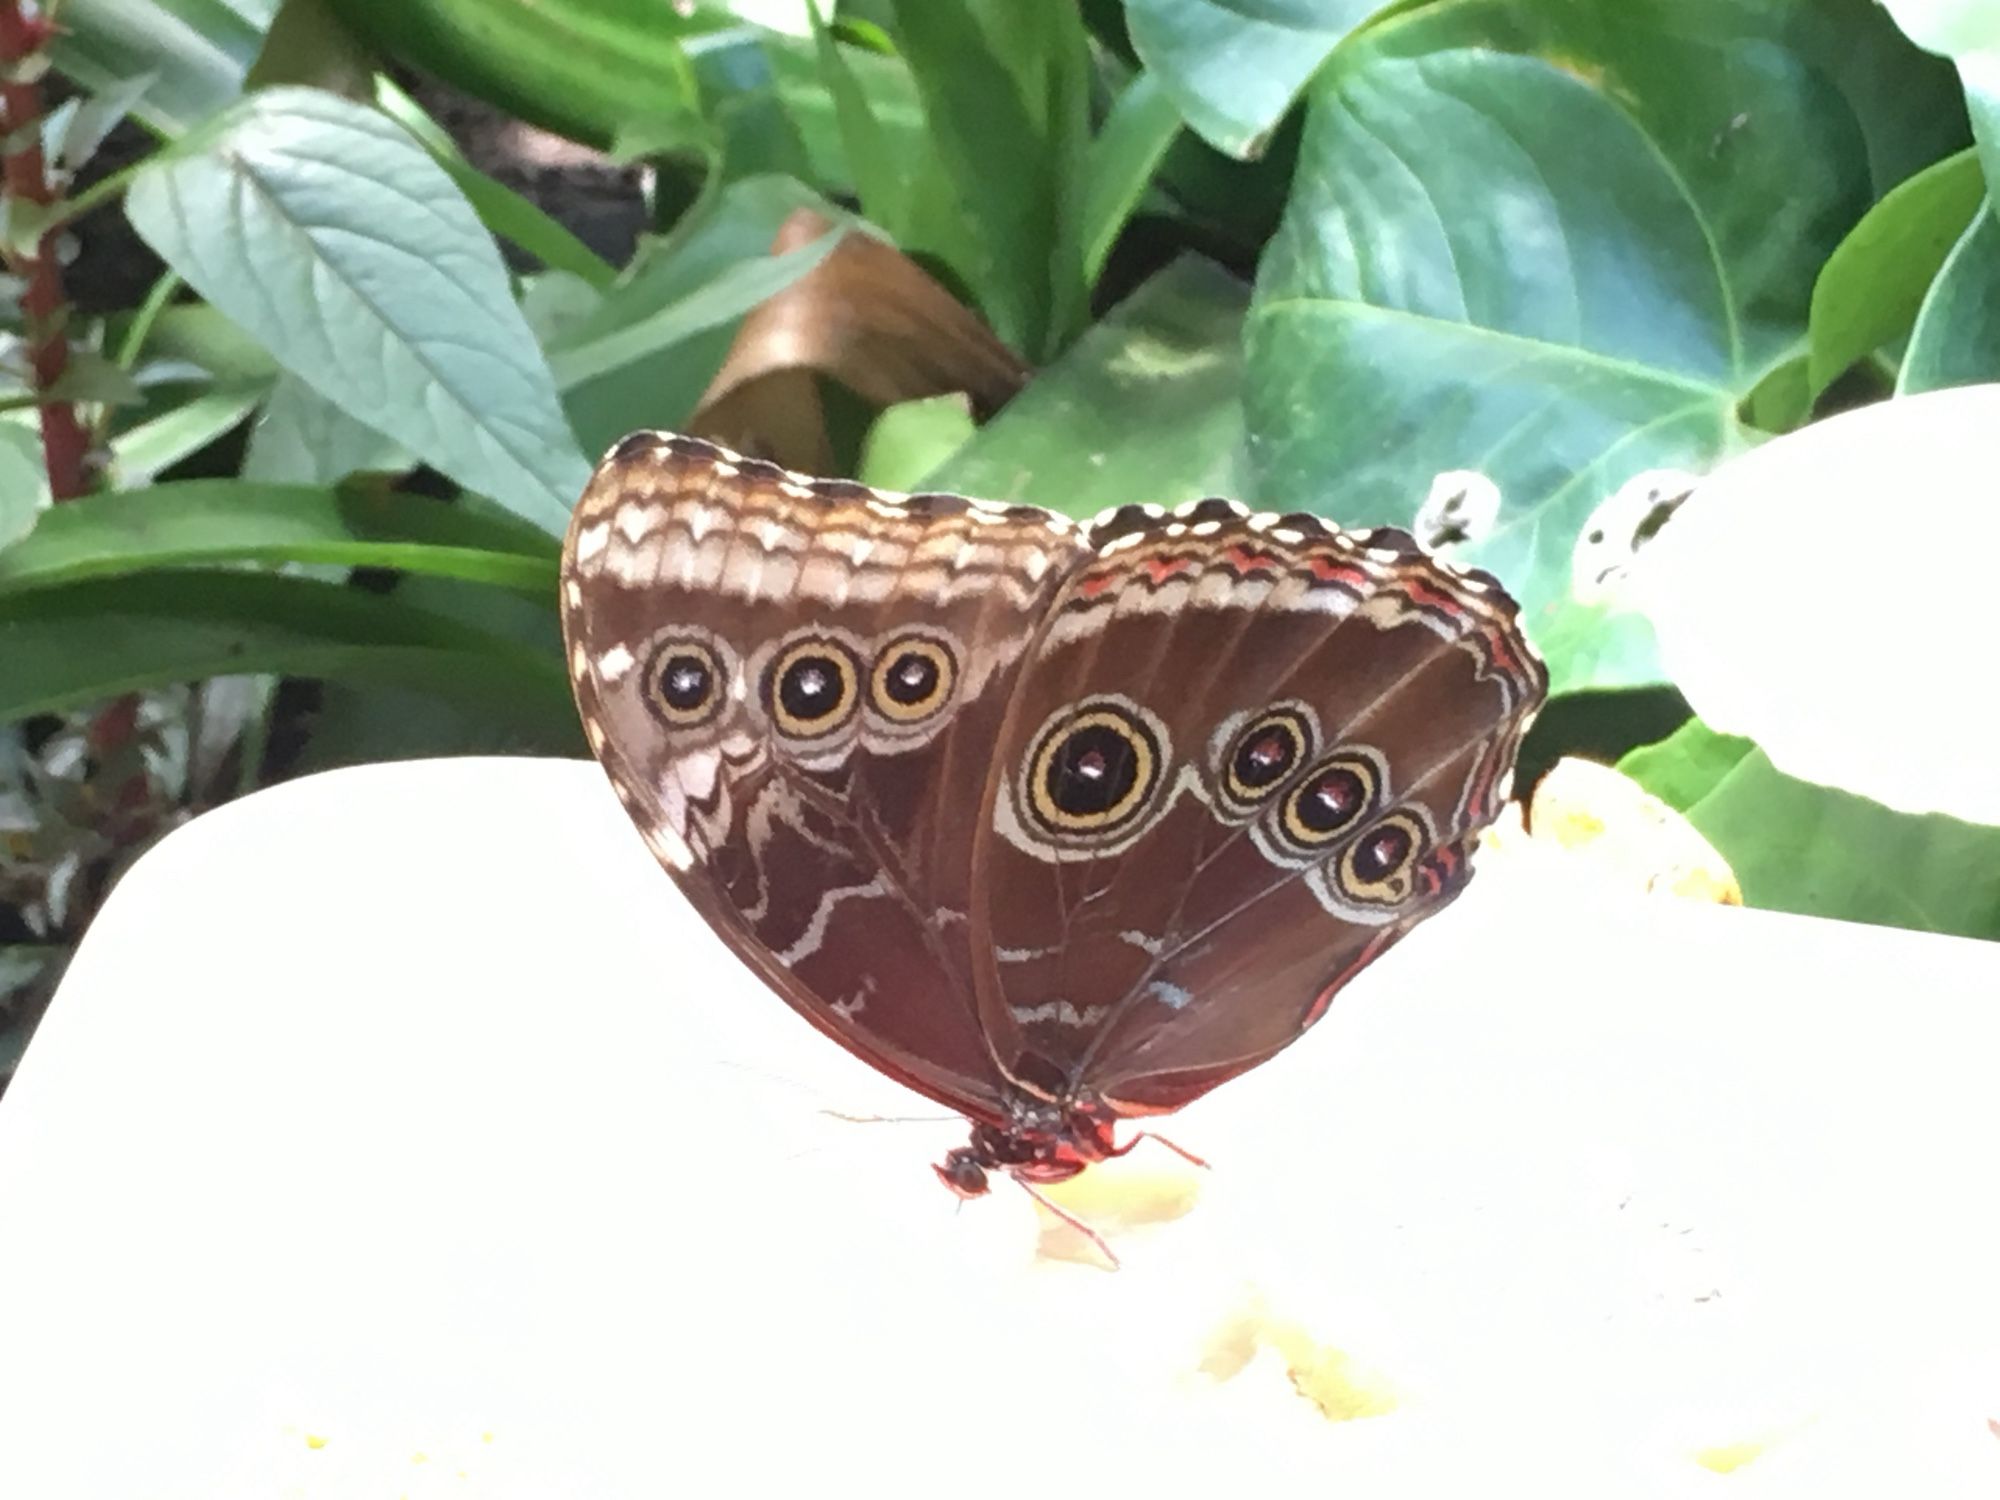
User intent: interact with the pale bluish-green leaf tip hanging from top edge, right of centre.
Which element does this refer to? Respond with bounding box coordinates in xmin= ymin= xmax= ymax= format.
xmin=1126 ymin=0 xmax=1380 ymax=158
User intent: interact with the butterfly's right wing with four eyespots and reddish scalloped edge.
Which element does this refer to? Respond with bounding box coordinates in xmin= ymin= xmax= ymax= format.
xmin=974 ymin=502 xmax=1544 ymax=1114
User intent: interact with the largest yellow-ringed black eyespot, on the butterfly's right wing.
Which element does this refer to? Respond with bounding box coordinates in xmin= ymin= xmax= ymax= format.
xmin=1022 ymin=698 xmax=1166 ymax=842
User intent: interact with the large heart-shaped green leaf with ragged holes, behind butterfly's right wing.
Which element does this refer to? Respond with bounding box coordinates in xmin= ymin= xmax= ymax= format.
xmin=1244 ymin=0 xmax=1964 ymax=690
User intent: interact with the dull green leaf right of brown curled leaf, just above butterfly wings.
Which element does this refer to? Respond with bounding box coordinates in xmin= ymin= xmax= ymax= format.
xmin=924 ymin=256 xmax=1248 ymax=516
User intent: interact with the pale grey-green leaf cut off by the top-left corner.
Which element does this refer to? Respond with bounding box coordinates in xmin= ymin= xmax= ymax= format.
xmin=50 ymin=0 xmax=278 ymax=136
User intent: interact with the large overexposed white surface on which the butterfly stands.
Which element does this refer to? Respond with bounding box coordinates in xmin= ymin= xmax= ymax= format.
xmin=0 ymin=762 xmax=2000 ymax=1500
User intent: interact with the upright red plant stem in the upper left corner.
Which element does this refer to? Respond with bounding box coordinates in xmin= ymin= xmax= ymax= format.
xmin=0 ymin=0 xmax=90 ymax=500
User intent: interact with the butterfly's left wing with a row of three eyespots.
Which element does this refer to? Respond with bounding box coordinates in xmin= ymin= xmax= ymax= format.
xmin=562 ymin=434 xmax=1086 ymax=1118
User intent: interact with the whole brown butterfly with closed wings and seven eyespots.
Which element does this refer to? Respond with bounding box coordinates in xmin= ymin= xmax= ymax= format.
xmin=562 ymin=434 xmax=1546 ymax=1224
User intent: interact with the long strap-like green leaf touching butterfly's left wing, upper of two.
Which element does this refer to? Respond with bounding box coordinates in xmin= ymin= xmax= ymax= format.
xmin=0 ymin=480 xmax=556 ymax=602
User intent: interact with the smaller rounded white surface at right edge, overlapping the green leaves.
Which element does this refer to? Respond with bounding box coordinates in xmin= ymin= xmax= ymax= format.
xmin=1632 ymin=376 xmax=2000 ymax=824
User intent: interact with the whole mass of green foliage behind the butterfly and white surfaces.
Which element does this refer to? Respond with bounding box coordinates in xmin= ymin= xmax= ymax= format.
xmin=0 ymin=0 xmax=2000 ymax=1078
